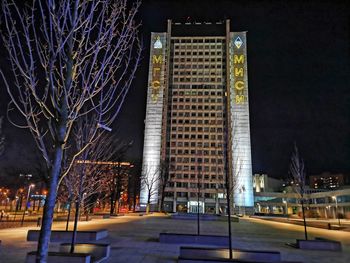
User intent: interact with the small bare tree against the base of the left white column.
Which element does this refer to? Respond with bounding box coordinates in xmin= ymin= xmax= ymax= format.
xmin=141 ymin=166 xmax=160 ymax=214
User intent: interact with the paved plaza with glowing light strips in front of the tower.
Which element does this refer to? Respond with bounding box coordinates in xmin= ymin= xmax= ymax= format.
xmin=0 ymin=214 xmax=350 ymax=263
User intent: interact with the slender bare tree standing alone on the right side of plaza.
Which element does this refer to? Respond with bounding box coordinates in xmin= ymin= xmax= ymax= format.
xmin=290 ymin=143 xmax=307 ymax=240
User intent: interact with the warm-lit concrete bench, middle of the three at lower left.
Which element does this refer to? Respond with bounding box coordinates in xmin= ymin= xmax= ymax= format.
xmin=59 ymin=243 xmax=111 ymax=263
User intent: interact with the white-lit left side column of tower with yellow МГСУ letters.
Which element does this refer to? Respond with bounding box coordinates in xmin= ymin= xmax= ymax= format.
xmin=140 ymin=33 xmax=166 ymax=209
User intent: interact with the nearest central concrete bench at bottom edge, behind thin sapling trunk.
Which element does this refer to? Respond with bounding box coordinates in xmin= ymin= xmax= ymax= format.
xmin=180 ymin=247 xmax=281 ymax=262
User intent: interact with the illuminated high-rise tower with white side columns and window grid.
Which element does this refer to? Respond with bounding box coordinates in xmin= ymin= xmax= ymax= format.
xmin=140 ymin=20 xmax=254 ymax=214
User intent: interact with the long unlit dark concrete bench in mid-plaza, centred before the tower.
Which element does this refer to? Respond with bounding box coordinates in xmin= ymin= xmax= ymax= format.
xmin=159 ymin=233 xmax=229 ymax=247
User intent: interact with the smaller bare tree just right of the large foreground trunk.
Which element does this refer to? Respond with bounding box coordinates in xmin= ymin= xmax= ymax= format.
xmin=62 ymin=115 xmax=122 ymax=253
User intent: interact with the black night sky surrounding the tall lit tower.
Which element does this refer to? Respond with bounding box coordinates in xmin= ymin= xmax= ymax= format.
xmin=0 ymin=0 xmax=350 ymax=180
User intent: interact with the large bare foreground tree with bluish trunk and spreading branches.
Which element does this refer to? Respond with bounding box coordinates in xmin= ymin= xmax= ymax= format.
xmin=0 ymin=0 xmax=141 ymax=262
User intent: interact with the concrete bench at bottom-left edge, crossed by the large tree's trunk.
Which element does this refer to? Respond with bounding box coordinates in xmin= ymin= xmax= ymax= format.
xmin=25 ymin=251 xmax=92 ymax=263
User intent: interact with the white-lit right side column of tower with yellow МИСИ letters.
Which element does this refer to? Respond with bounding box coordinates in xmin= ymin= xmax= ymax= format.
xmin=229 ymin=32 xmax=254 ymax=207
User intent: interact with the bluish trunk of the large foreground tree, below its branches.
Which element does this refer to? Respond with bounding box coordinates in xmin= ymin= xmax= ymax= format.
xmin=36 ymin=145 xmax=63 ymax=263
